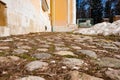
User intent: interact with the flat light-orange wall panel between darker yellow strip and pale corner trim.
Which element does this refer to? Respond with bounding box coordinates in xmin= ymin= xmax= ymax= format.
xmin=55 ymin=0 xmax=68 ymax=26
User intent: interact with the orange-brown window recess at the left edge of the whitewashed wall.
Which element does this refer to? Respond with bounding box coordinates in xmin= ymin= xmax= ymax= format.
xmin=0 ymin=1 xmax=7 ymax=26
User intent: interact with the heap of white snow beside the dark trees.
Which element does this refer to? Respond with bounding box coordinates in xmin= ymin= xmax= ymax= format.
xmin=74 ymin=20 xmax=120 ymax=36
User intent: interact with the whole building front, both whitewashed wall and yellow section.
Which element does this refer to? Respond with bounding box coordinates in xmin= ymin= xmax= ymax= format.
xmin=0 ymin=0 xmax=76 ymax=36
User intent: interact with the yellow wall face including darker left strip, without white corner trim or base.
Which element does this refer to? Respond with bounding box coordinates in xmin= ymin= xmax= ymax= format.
xmin=51 ymin=0 xmax=68 ymax=26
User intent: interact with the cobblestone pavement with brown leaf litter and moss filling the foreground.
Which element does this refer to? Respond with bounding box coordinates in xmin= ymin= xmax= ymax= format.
xmin=0 ymin=33 xmax=120 ymax=80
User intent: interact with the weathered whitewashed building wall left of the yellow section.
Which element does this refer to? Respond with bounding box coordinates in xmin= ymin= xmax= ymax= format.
xmin=0 ymin=0 xmax=51 ymax=36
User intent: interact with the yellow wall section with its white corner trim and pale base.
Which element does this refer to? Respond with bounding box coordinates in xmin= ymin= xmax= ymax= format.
xmin=51 ymin=0 xmax=76 ymax=32
